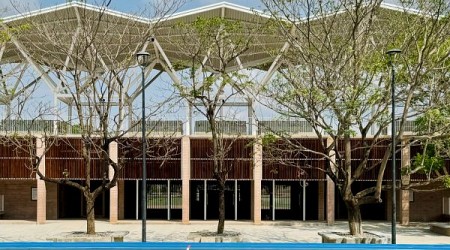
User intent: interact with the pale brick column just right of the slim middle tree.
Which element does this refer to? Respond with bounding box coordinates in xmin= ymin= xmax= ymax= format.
xmin=252 ymin=139 xmax=263 ymax=224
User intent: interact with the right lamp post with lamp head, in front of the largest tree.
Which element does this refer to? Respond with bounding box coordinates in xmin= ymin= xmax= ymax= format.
xmin=386 ymin=49 xmax=402 ymax=244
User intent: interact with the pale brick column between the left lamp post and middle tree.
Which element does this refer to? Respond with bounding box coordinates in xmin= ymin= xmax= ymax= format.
xmin=181 ymin=136 xmax=191 ymax=224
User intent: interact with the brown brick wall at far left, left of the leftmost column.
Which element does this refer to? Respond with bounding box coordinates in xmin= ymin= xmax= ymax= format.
xmin=0 ymin=180 xmax=37 ymax=220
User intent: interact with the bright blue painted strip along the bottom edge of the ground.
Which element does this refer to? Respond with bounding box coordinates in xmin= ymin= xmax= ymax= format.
xmin=0 ymin=242 xmax=450 ymax=250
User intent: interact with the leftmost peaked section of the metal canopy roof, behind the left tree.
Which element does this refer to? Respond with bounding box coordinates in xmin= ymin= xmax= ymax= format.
xmin=1 ymin=2 xmax=151 ymax=69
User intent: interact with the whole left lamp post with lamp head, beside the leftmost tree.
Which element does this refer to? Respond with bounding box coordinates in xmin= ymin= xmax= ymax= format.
xmin=136 ymin=51 xmax=150 ymax=242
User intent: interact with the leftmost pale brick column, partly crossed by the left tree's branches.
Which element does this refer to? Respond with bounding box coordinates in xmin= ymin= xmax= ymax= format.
xmin=36 ymin=137 xmax=47 ymax=224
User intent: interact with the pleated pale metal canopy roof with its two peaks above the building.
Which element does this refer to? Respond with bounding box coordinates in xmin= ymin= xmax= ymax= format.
xmin=1 ymin=2 xmax=285 ymax=71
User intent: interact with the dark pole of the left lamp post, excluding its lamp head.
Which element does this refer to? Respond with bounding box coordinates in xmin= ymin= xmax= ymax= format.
xmin=141 ymin=67 xmax=147 ymax=242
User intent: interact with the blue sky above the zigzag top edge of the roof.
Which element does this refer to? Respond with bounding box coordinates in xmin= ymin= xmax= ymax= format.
xmin=0 ymin=0 xmax=263 ymax=17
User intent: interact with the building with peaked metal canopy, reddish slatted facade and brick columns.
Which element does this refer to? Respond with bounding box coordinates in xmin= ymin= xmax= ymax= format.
xmin=0 ymin=2 xmax=449 ymax=227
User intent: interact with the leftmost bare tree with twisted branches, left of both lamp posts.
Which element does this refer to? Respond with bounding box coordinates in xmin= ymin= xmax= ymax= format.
xmin=2 ymin=1 xmax=181 ymax=234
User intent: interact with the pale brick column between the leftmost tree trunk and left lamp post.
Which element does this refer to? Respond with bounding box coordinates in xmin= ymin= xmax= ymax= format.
xmin=108 ymin=142 xmax=119 ymax=223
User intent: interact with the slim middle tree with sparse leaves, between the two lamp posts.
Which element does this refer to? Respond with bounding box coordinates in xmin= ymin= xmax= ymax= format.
xmin=167 ymin=17 xmax=268 ymax=234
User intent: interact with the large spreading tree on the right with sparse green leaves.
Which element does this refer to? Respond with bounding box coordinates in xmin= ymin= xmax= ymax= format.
xmin=263 ymin=0 xmax=448 ymax=235
